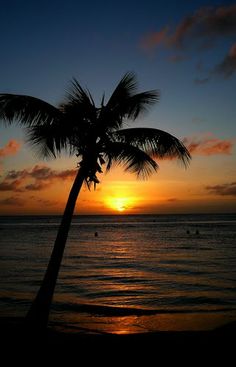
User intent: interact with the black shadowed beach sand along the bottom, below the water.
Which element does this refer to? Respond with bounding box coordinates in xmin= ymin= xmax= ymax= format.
xmin=0 ymin=318 xmax=236 ymax=366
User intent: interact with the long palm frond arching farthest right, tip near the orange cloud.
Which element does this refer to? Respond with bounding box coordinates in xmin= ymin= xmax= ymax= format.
xmin=113 ymin=128 xmax=191 ymax=166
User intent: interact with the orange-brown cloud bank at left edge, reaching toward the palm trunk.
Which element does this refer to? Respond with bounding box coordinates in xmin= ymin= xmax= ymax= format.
xmin=0 ymin=165 xmax=76 ymax=192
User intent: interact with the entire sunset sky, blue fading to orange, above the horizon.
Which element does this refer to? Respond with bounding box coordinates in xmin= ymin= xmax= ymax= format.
xmin=0 ymin=0 xmax=236 ymax=215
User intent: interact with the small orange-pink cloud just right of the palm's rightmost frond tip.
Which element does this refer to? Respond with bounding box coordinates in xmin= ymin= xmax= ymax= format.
xmin=183 ymin=134 xmax=234 ymax=156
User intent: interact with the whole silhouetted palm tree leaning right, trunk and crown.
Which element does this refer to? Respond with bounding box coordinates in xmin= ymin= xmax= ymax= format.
xmin=0 ymin=73 xmax=190 ymax=329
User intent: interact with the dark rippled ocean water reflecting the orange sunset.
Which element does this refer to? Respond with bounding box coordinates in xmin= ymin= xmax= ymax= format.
xmin=0 ymin=214 xmax=236 ymax=333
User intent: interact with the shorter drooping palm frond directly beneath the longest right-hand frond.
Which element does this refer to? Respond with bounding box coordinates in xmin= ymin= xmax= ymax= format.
xmin=103 ymin=142 xmax=158 ymax=178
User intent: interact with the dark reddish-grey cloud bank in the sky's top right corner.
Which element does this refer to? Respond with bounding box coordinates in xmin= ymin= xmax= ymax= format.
xmin=141 ymin=4 xmax=236 ymax=80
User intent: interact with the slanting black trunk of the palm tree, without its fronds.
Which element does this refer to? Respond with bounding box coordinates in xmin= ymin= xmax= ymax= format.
xmin=25 ymin=167 xmax=85 ymax=331
